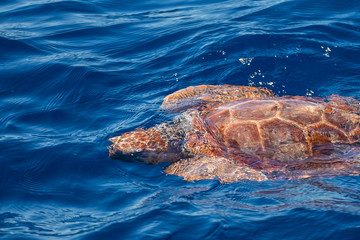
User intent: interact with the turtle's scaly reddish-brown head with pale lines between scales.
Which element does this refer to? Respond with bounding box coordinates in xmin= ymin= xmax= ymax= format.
xmin=108 ymin=127 xmax=180 ymax=164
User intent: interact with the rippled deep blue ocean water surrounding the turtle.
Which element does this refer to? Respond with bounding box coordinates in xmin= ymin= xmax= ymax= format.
xmin=0 ymin=0 xmax=360 ymax=239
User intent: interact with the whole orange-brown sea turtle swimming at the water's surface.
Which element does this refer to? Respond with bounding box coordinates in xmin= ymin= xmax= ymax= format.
xmin=108 ymin=85 xmax=360 ymax=183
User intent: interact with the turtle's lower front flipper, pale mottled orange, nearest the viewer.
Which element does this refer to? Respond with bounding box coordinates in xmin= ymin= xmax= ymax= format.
xmin=165 ymin=156 xmax=268 ymax=183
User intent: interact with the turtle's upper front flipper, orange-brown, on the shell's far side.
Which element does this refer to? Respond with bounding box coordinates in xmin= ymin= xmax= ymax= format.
xmin=161 ymin=85 xmax=274 ymax=112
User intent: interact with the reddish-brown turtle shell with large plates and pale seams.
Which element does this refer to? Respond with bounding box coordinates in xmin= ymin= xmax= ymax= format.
xmin=204 ymin=97 xmax=360 ymax=165
